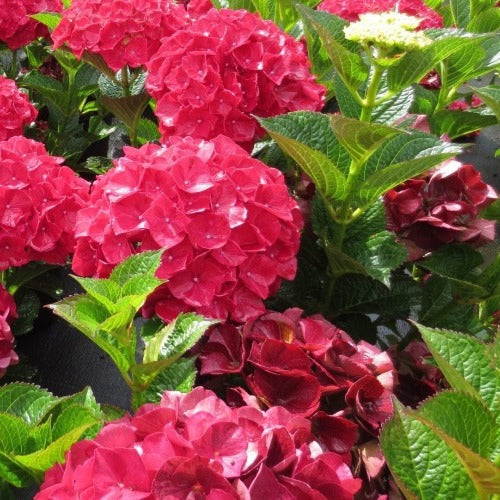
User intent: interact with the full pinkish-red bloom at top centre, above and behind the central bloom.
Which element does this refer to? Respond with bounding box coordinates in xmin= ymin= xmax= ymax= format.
xmin=146 ymin=9 xmax=325 ymax=148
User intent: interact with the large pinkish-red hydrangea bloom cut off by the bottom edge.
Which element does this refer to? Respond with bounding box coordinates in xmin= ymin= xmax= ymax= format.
xmin=35 ymin=387 xmax=361 ymax=500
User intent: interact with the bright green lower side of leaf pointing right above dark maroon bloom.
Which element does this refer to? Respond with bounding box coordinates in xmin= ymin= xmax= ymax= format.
xmin=357 ymin=145 xmax=456 ymax=206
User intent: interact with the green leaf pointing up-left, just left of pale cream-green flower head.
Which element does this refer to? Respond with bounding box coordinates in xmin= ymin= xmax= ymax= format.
xmin=297 ymin=6 xmax=369 ymax=91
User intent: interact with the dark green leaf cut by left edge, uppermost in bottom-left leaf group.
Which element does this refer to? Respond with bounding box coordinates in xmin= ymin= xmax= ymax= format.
xmin=0 ymin=382 xmax=57 ymax=426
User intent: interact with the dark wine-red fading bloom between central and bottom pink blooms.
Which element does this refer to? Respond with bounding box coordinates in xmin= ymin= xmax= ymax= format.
xmin=200 ymin=308 xmax=395 ymax=434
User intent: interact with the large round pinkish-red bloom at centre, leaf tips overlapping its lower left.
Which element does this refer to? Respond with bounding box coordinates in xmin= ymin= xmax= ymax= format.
xmin=73 ymin=136 xmax=302 ymax=321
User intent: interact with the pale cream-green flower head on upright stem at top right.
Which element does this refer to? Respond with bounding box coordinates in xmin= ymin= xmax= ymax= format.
xmin=344 ymin=12 xmax=432 ymax=52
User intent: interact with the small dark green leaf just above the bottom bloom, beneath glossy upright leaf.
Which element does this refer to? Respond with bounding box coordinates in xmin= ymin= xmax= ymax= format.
xmin=141 ymin=358 xmax=196 ymax=403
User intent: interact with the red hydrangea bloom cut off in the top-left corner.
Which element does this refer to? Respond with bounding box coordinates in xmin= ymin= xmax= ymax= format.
xmin=0 ymin=0 xmax=62 ymax=50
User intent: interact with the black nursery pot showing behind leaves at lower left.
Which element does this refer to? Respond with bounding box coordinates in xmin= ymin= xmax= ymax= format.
xmin=16 ymin=268 xmax=131 ymax=410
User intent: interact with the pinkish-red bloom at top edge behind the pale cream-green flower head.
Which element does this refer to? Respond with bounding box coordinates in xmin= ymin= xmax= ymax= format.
xmin=318 ymin=0 xmax=443 ymax=29
